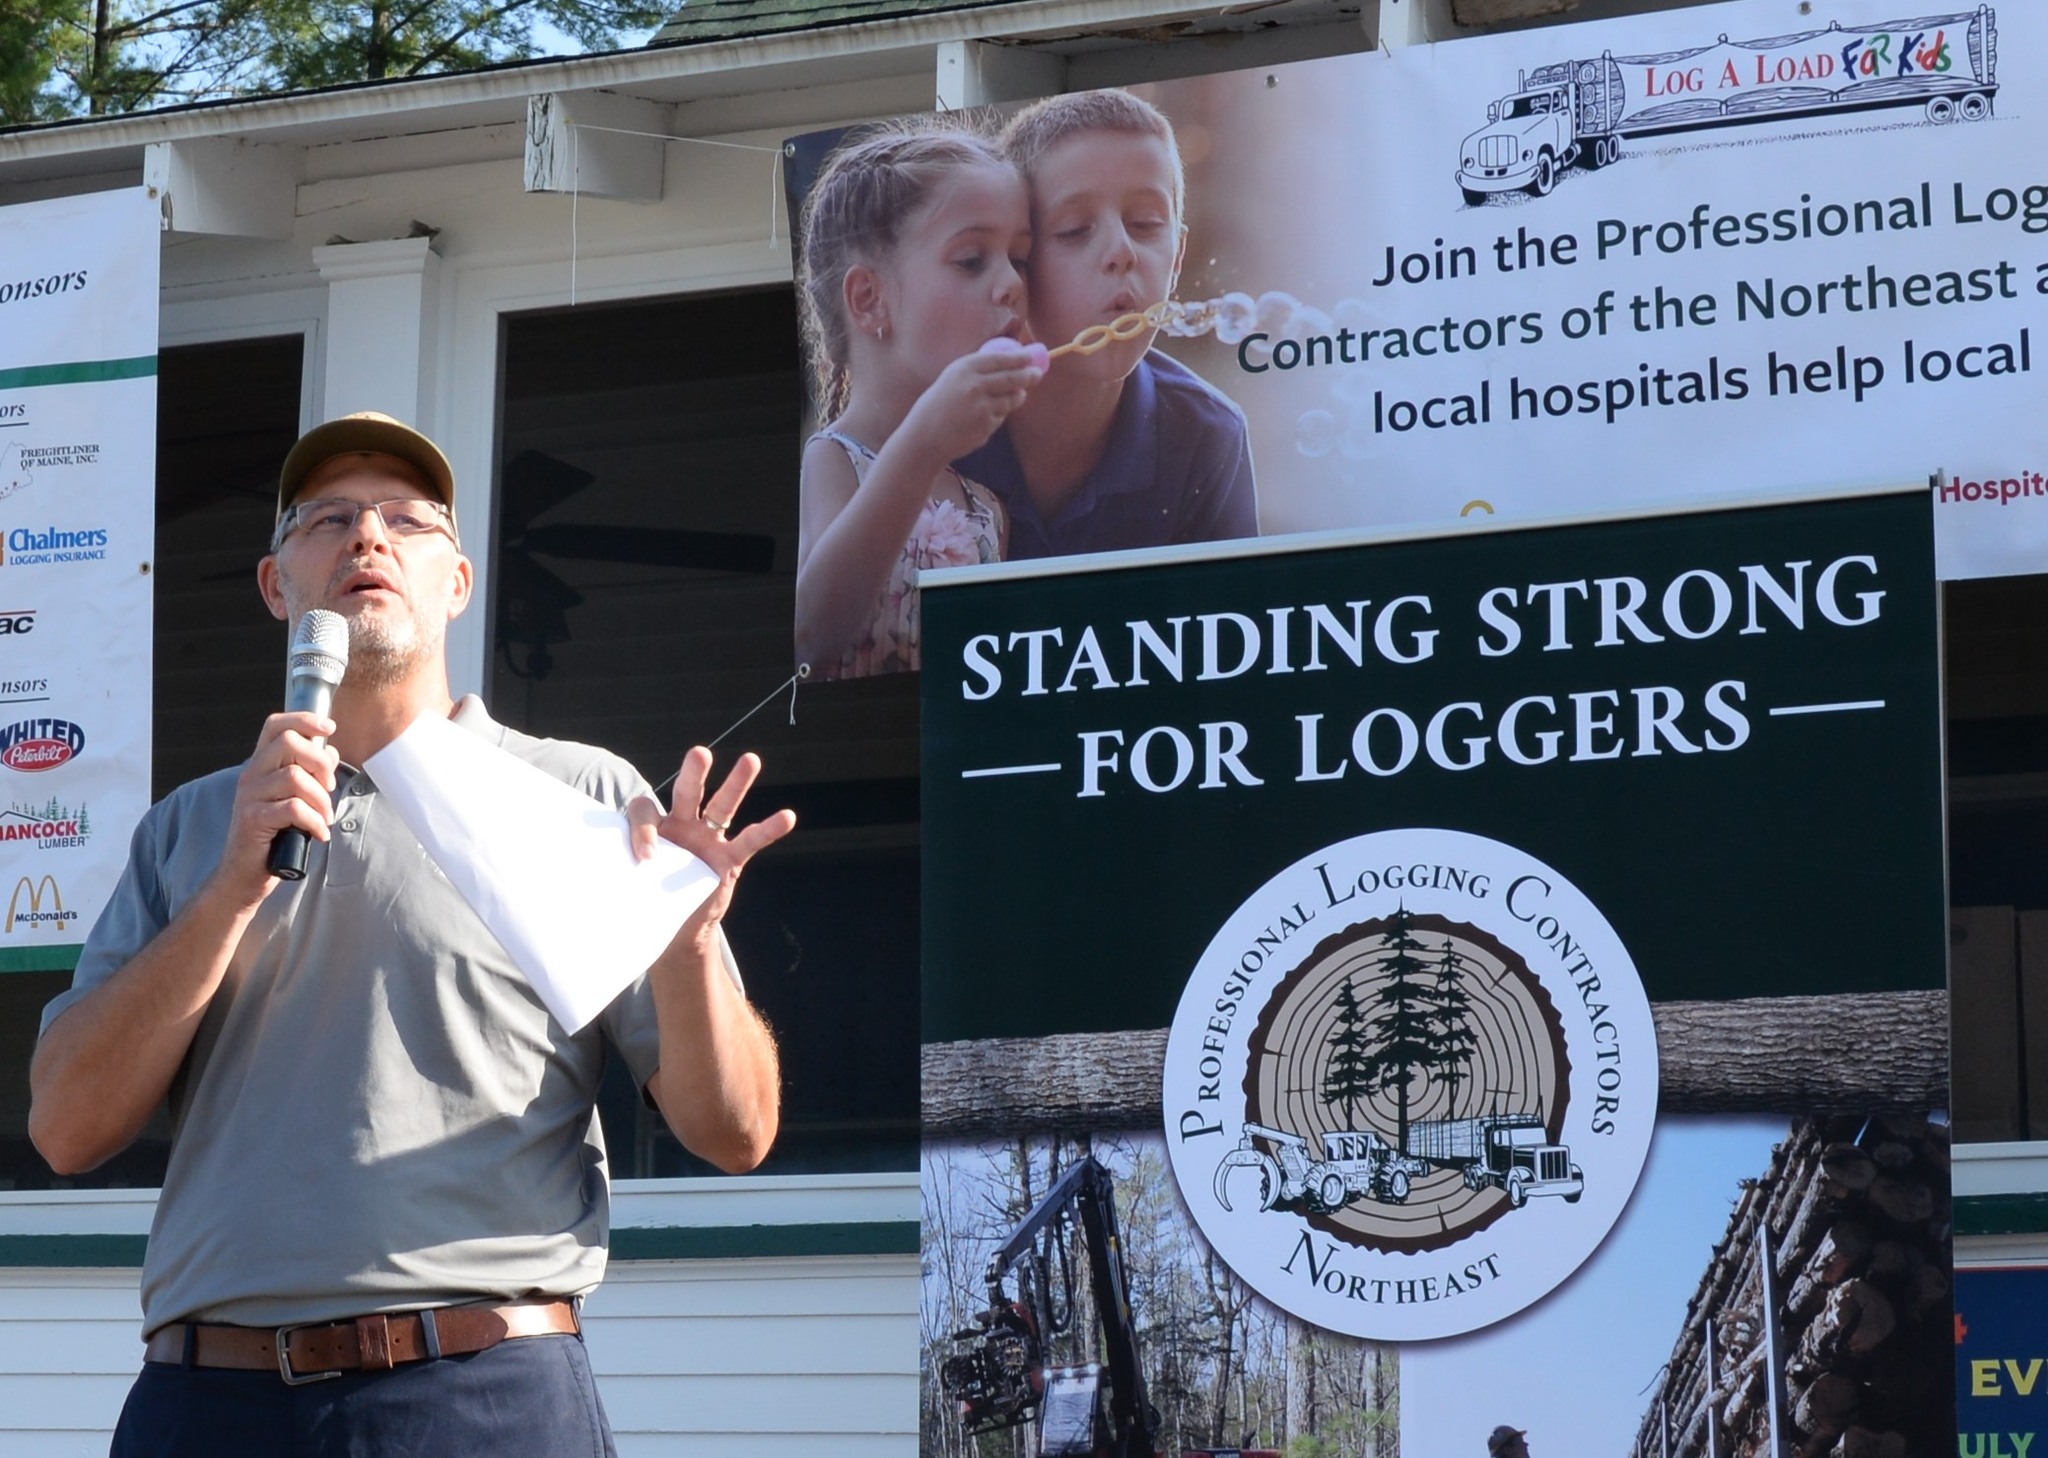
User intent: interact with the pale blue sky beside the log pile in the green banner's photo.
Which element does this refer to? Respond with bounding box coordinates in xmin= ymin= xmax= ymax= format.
xmin=1401 ymin=1116 xmax=1790 ymax=1458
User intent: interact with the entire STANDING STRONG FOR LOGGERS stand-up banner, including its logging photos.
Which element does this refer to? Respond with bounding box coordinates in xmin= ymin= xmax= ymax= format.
xmin=922 ymin=485 xmax=1948 ymax=1454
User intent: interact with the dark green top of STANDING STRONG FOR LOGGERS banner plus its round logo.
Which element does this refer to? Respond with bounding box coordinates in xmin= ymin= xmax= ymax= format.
xmin=924 ymin=487 xmax=1946 ymax=1339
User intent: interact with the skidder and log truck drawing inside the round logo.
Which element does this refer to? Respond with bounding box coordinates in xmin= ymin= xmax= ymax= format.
xmin=1217 ymin=1114 xmax=1585 ymax=1214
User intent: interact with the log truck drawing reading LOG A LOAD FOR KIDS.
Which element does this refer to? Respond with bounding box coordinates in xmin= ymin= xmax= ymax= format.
xmin=1458 ymin=4 xmax=1999 ymax=205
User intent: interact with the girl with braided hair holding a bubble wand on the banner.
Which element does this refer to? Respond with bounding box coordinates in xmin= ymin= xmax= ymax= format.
xmin=797 ymin=131 xmax=1047 ymax=678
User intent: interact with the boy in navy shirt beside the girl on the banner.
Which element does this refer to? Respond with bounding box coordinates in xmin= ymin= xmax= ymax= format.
xmin=958 ymin=90 xmax=1260 ymax=559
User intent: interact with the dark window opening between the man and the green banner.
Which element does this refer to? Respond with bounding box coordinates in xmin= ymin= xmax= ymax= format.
xmin=491 ymin=289 xmax=918 ymax=1175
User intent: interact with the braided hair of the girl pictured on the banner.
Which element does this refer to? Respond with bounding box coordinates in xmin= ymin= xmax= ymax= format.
xmin=797 ymin=123 xmax=1010 ymax=420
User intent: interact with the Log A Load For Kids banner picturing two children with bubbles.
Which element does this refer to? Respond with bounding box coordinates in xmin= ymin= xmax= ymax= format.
xmin=795 ymin=0 xmax=2048 ymax=674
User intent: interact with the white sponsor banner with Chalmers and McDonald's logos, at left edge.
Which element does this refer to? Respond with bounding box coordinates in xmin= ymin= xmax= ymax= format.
xmin=0 ymin=188 xmax=162 ymax=971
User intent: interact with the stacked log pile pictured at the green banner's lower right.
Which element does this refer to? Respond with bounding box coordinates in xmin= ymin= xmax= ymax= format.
xmin=1632 ymin=1114 xmax=1954 ymax=1458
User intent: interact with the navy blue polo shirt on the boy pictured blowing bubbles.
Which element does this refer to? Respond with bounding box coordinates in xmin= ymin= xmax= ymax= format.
xmin=956 ymin=350 xmax=1260 ymax=561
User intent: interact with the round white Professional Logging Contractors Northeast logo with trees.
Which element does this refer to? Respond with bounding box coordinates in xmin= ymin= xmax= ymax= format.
xmin=1163 ymin=829 xmax=1657 ymax=1341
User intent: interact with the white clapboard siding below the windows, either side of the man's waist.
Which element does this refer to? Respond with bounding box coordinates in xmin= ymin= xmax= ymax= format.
xmin=0 ymin=1173 xmax=918 ymax=1458
